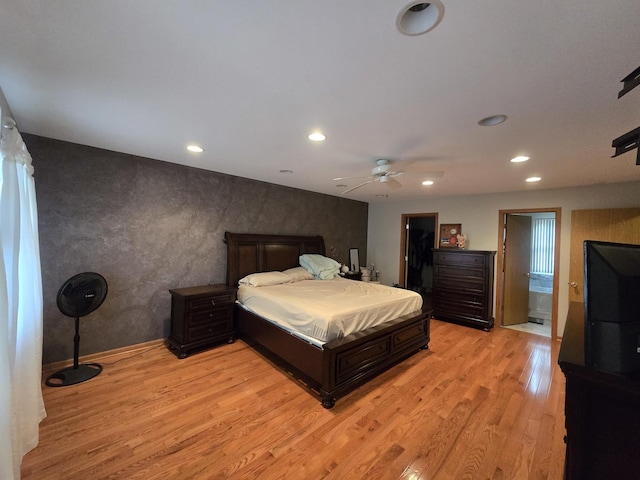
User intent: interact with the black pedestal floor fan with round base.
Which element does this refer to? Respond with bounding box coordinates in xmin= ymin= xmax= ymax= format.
xmin=45 ymin=272 xmax=107 ymax=387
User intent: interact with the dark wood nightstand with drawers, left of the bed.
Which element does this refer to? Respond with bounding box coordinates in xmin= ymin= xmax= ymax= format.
xmin=168 ymin=285 xmax=237 ymax=358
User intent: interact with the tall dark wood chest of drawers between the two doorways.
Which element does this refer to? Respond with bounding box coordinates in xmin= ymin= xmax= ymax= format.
xmin=433 ymin=248 xmax=496 ymax=331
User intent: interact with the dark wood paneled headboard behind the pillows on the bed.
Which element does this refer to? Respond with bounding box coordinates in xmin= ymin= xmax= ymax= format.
xmin=224 ymin=232 xmax=325 ymax=286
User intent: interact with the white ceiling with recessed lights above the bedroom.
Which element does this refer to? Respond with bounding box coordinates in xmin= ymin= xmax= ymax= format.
xmin=0 ymin=0 xmax=640 ymax=202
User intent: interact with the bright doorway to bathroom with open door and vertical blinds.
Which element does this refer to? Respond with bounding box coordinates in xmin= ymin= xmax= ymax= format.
xmin=496 ymin=208 xmax=561 ymax=339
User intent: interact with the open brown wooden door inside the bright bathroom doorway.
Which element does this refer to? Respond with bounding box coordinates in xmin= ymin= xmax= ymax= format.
xmin=502 ymin=214 xmax=531 ymax=325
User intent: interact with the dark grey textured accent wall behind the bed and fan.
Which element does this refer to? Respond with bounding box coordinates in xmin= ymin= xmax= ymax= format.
xmin=23 ymin=134 xmax=368 ymax=363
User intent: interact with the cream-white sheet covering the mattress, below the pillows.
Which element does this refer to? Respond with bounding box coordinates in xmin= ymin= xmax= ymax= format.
xmin=238 ymin=277 xmax=422 ymax=343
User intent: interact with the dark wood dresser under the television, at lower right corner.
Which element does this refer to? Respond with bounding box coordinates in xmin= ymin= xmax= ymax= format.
xmin=558 ymin=302 xmax=640 ymax=480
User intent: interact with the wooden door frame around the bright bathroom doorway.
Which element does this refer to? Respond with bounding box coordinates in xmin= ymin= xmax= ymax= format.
xmin=495 ymin=207 xmax=562 ymax=340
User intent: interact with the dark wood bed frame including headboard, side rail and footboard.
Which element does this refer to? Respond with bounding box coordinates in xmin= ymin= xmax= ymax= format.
xmin=225 ymin=232 xmax=430 ymax=408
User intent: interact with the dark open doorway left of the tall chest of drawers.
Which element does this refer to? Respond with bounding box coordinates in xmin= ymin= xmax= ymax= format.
xmin=399 ymin=213 xmax=438 ymax=306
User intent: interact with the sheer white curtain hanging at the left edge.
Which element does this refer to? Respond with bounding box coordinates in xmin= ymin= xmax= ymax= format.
xmin=0 ymin=118 xmax=46 ymax=480
